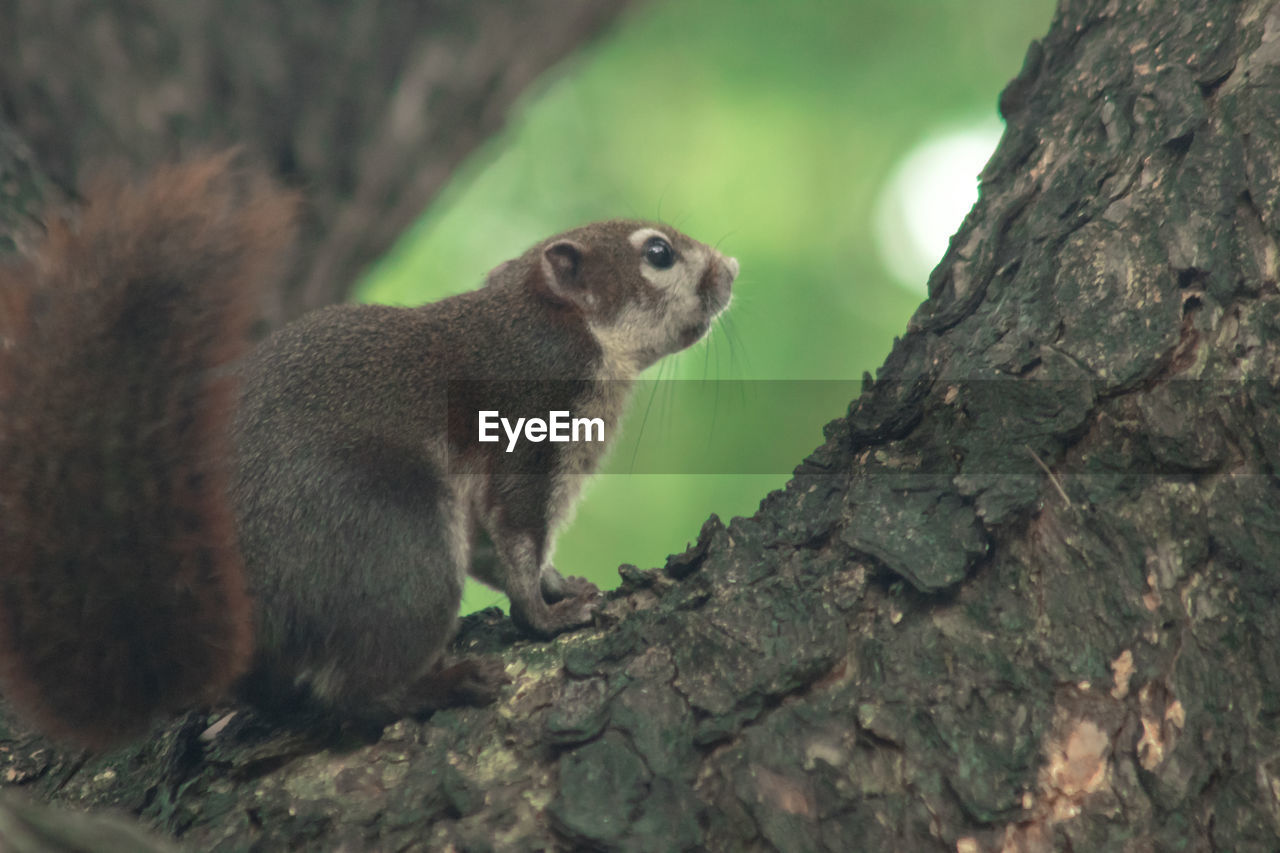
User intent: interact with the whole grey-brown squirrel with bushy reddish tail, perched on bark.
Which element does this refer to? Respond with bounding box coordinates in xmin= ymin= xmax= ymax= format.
xmin=0 ymin=155 xmax=739 ymax=747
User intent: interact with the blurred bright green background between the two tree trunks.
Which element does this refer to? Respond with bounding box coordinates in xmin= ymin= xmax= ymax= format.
xmin=360 ymin=0 xmax=1053 ymax=610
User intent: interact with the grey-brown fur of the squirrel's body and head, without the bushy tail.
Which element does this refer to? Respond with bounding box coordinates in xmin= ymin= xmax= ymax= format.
xmin=234 ymin=213 xmax=736 ymax=717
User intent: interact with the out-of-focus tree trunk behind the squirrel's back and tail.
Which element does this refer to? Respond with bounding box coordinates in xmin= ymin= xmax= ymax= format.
xmin=0 ymin=0 xmax=627 ymax=325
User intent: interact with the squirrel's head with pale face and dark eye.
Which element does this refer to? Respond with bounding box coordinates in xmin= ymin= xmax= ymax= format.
xmin=490 ymin=219 xmax=737 ymax=378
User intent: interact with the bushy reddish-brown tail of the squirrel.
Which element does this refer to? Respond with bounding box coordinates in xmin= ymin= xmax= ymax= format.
xmin=0 ymin=155 xmax=294 ymax=745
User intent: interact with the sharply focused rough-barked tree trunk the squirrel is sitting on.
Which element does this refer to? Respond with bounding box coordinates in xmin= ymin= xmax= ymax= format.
xmin=6 ymin=0 xmax=1280 ymax=850
